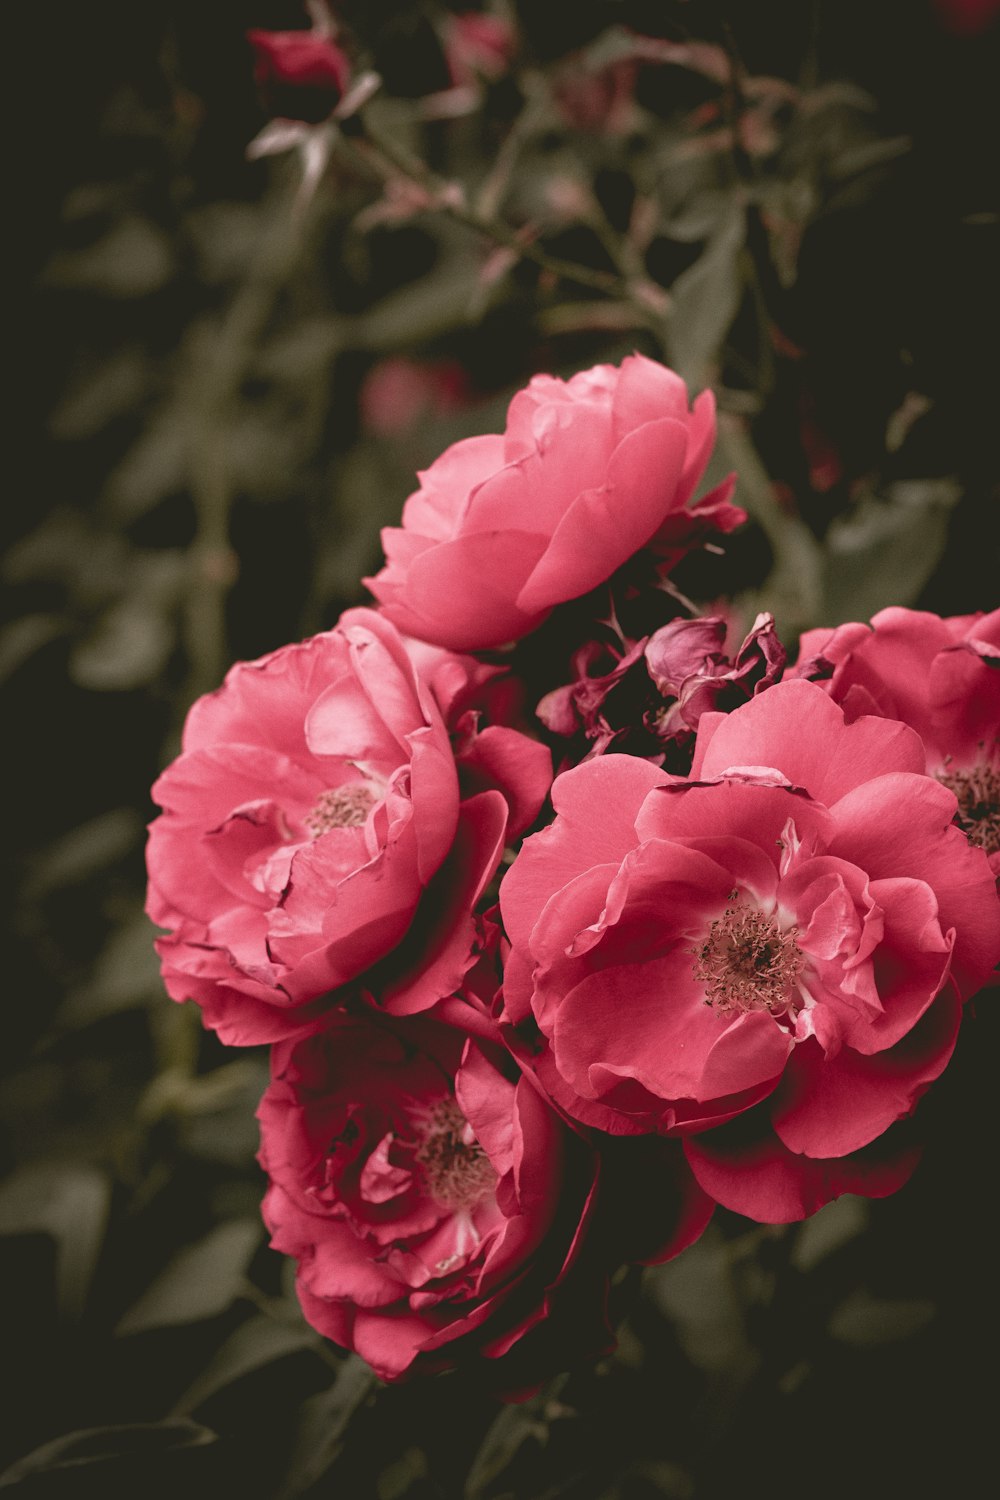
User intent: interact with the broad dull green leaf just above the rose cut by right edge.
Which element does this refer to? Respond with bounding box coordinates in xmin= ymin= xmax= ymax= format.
xmin=825 ymin=479 xmax=960 ymax=626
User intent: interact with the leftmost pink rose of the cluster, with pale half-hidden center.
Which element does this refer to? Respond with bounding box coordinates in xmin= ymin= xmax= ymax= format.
xmin=147 ymin=609 xmax=550 ymax=1044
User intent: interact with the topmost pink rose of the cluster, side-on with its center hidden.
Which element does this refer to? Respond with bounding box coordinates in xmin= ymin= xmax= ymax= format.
xmin=366 ymin=354 xmax=742 ymax=651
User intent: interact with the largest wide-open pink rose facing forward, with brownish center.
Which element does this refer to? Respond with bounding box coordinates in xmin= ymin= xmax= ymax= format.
xmin=501 ymin=683 xmax=1000 ymax=1223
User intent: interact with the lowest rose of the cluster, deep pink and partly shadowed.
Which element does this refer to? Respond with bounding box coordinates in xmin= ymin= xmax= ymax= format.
xmin=258 ymin=1014 xmax=613 ymax=1388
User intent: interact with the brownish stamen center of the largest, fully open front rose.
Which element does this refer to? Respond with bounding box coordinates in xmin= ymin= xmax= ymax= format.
xmin=694 ymin=891 xmax=804 ymax=1016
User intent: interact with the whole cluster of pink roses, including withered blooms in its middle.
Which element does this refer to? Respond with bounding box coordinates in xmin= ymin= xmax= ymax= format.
xmin=148 ymin=356 xmax=1000 ymax=1392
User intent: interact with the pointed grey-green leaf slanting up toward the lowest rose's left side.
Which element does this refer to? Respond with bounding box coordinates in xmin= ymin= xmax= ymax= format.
xmin=115 ymin=1220 xmax=262 ymax=1335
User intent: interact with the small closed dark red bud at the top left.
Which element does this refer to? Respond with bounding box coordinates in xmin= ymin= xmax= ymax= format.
xmin=246 ymin=30 xmax=351 ymax=125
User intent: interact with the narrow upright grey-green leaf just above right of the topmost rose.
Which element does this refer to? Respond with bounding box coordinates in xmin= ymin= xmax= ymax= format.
xmin=669 ymin=200 xmax=747 ymax=389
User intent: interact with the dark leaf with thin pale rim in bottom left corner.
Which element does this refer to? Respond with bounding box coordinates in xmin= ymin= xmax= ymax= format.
xmin=0 ymin=1419 xmax=216 ymax=1500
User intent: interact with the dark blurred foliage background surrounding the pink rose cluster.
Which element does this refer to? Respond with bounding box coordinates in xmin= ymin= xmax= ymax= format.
xmin=0 ymin=0 xmax=1000 ymax=1500
